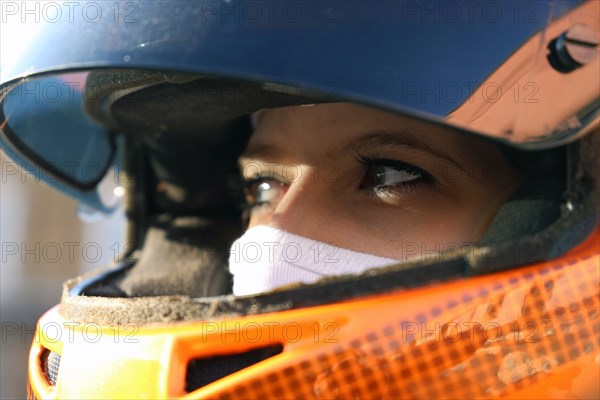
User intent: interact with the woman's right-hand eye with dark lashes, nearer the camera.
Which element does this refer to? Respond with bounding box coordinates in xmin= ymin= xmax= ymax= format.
xmin=361 ymin=159 xmax=433 ymax=192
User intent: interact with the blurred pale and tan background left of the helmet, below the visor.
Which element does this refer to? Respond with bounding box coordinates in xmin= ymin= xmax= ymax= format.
xmin=0 ymin=152 xmax=125 ymax=399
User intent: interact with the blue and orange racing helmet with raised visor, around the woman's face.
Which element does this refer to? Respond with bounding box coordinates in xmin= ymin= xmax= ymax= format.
xmin=0 ymin=0 xmax=600 ymax=398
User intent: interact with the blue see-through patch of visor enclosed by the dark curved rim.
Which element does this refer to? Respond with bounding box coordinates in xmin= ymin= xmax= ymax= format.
xmin=2 ymin=74 xmax=113 ymax=186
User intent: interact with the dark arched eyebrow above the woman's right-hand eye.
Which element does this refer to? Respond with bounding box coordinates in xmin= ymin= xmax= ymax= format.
xmin=327 ymin=129 xmax=464 ymax=170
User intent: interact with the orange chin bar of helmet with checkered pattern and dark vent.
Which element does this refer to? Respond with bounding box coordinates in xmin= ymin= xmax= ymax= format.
xmin=28 ymin=229 xmax=600 ymax=399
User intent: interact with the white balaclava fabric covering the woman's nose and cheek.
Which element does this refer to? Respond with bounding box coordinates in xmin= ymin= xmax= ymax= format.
xmin=229 ymin=225 xmax=399 ymax=296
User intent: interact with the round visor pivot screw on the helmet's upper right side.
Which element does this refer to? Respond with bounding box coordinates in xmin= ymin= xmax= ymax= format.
xmin=548 ymin=24 xmax=599 ymax=72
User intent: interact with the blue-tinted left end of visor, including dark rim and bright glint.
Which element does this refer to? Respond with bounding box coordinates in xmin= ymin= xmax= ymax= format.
xmin=0 ymin=72 xmax=124 ymax=214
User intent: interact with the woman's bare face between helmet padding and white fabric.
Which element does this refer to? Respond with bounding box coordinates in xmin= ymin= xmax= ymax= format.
xmin=240 ymin=103 xmax=520 ymax=260
